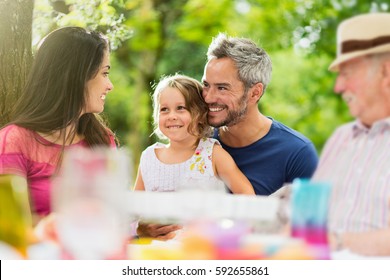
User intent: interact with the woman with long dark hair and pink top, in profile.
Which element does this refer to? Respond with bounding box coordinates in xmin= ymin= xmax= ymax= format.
xmin=0 ymin=27 xmax=116 ymax=223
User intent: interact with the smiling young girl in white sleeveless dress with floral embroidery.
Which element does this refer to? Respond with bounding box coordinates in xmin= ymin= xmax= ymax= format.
xmin=135 ymin=75 xmax=255 ymax=194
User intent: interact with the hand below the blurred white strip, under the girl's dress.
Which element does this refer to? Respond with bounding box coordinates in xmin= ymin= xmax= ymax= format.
xmin=137 ymin=222 xmax=183 ymax=240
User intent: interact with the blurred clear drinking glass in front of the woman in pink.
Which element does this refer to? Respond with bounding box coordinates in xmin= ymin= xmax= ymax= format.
xmin=53 ymin=148 xmax=130 ymax=260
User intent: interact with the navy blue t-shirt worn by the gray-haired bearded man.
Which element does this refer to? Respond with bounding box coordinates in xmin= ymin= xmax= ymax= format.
xmin=214 ymin=119 xmax=318 ymax=195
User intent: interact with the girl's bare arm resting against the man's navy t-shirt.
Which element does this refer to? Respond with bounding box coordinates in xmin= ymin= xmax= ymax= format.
xmin=213 ymin=145 xmax=255 ymax=194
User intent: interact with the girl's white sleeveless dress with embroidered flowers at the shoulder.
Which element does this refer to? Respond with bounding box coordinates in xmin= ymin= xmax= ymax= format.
xmin=140 ymin=138 xmax=225 ymax=192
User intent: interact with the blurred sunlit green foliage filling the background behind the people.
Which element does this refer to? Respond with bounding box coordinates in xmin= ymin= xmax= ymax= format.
xmin=29 ymin=0 xmax=389 ymax=166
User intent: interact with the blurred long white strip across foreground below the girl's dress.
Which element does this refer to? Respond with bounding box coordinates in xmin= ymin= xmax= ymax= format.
xmin=127 ymin=188 xmax=280 ymax=232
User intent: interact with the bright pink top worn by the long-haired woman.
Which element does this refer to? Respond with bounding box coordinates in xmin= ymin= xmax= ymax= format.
xmin=0 ymin=125 xmax=116 ymax=215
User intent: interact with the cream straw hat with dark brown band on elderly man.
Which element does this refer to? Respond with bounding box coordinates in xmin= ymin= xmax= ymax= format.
xmin=329 ymin=13 xmax=390 ymax=72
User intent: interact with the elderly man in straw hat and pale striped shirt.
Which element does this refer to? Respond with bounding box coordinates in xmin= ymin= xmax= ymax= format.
xmin=313 ymin=13 xmax=390 ymax=255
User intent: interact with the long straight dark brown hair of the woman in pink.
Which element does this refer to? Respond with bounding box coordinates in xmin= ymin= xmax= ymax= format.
xmin=11 ymin=27 xmax=113 ymax=147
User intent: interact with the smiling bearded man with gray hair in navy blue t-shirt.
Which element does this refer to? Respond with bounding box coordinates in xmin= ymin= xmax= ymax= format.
xmin=202 ymin=33 xmax=318 ymax=195
